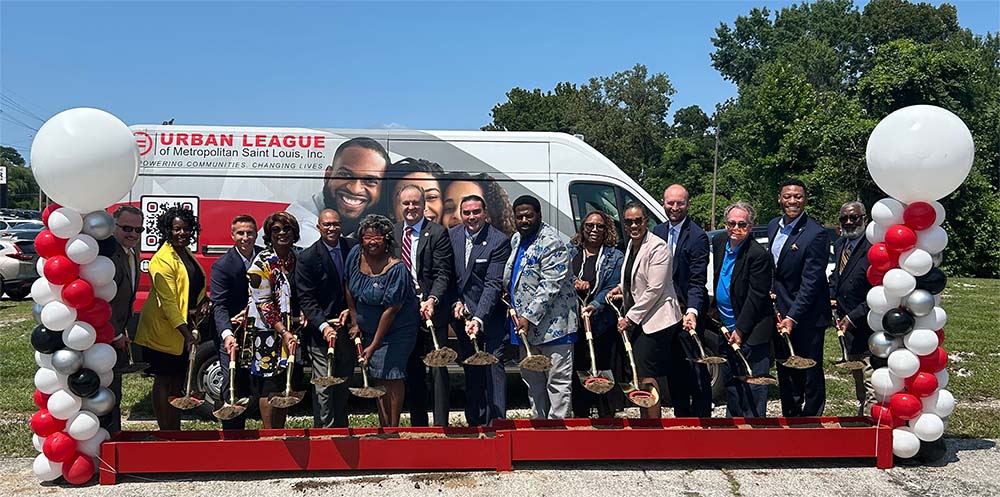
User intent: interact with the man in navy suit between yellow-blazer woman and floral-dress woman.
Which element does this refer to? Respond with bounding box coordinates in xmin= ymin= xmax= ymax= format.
xmin=209 ymin=214 xmax=260 ymax=430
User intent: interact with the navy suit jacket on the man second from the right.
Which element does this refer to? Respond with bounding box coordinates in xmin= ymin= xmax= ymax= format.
xmin=767 ymin=212 xmax=830 ymax=329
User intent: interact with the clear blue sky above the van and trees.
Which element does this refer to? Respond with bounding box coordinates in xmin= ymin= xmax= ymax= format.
xmin=0 ymin=0 xmax=1000 ymax=161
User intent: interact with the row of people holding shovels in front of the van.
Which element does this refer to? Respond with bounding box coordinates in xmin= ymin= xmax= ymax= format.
xmin=103 ymin=168 xmax=873 ymax=430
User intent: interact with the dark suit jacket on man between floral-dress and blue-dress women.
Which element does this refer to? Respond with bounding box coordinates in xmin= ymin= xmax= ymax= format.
xmin=293 ymin=238 xmax=352 ymax=348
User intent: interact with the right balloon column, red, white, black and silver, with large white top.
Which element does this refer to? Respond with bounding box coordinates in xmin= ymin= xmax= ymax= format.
xmin=866 ymin=105 xmax=975 ymax=458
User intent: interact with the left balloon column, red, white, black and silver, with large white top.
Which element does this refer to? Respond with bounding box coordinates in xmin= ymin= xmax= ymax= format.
xmin=31 ymin=108 xmax=139 ymax=485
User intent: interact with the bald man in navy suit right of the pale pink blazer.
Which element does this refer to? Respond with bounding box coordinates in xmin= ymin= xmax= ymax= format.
xmin=653 ymin=185 xmax=712 ymax=418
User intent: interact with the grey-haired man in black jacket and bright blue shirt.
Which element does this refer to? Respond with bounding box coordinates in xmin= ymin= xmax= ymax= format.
xmin=712 ymin=202 xmax=776 ymax=418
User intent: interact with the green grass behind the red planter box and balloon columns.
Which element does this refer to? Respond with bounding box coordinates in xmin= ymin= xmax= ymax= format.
xmin=0 ymin=278 xmax=1000 ymax=456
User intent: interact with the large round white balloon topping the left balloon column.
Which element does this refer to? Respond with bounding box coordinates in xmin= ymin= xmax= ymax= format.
xmin=31 ymin=107 xmax=139 ymax=212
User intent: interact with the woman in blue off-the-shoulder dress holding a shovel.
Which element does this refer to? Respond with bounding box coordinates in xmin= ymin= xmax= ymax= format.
xmin=347 ymin=214 xmax=420 ymax=426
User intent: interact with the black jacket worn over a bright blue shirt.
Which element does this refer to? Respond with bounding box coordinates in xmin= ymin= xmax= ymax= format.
xmin=712 ymin=233 xmax=777 ymax=345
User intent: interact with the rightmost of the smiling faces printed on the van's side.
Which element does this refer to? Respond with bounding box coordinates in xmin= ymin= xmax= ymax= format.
xmin=440 ymin=171 xmax=515 ymax=237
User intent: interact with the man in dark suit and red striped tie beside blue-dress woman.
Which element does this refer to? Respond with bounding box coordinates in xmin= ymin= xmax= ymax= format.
xmin=393 ymin=184 xmax=454 ymax=426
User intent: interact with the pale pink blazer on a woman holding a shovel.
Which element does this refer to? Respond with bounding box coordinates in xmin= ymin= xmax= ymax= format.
xmin=622 ymin=232 xmax=682 ymax=333
